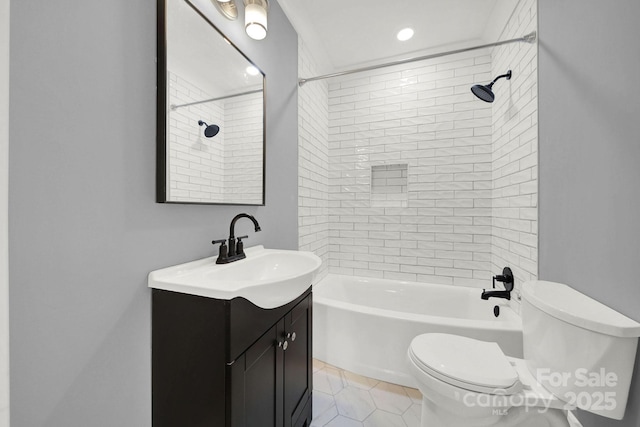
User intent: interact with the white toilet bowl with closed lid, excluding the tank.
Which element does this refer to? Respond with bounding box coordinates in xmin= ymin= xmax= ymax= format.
xmin=408 ymin=334 xmax=568 ymax=427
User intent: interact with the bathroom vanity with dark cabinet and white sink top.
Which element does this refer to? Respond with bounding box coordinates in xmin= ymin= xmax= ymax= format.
xmin=149 ymin=246 xmax=321 ymax=427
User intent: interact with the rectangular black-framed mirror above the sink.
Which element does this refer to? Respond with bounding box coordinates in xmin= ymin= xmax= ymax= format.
xmin=156 ymin=0 xmax=265 ymax=205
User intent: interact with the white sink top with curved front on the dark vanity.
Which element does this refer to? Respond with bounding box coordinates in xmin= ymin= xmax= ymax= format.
xmin=148 ymin=246 xmax=322 ymax=308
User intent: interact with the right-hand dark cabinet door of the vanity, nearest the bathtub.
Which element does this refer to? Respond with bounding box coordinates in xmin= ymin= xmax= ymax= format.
xmin=283 ymin=296 xmax=312 ymax=427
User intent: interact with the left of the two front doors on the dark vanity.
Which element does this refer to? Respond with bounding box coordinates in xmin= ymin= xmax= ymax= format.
xmin=227 ymin=320 xmax=284 ymax=427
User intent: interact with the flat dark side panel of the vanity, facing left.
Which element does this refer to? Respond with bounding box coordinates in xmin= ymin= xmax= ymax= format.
xmin=151 ymin=289 xmax=227 ymax=427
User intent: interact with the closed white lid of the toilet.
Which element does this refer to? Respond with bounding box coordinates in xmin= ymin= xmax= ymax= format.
xmin=410 ymin=334 xmax=520 ymax=393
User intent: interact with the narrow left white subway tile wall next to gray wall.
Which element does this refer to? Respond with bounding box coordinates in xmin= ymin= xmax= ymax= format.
xmin=298 ymin=38 xmax=329 ymax=280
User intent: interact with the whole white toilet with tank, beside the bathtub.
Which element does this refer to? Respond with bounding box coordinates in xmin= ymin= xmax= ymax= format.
xmin=408 ymin=281 xmax=640 ymax=427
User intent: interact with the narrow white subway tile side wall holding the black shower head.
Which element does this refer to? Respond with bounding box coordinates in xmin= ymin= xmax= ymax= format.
xmin=491 ymin=0 xmax=538 ymax=308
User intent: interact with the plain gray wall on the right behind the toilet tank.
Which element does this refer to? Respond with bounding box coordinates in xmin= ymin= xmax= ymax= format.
xmin=539 ymin=0 xmax=640 ymax=427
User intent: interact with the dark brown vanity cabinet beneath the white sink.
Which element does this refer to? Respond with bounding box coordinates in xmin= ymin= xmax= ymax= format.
xmin=152 ymin=288 xmax=312 ymax=427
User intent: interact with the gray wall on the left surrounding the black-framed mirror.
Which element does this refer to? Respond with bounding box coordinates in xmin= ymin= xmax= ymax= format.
xmin=9 ymin=0 xmax=298 ymax=427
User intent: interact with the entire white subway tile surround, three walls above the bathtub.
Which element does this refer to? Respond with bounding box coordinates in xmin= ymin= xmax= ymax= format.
xmin=298 ymin=0 xmax=537 ymax=287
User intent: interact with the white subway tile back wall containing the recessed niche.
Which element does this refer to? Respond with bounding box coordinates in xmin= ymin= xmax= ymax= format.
xmin=329 ymin=50 xmax=492 ymax=286
